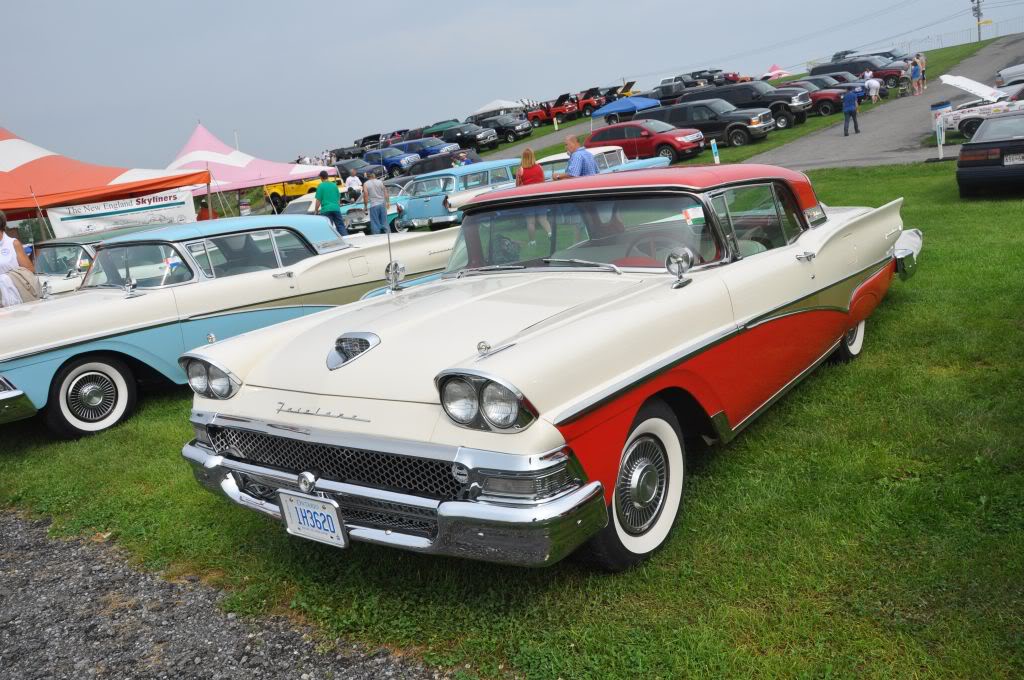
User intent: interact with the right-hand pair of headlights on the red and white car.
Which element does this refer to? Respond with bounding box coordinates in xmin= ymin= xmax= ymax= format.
xmin=436 ymin=372 xmax=537 ymax=432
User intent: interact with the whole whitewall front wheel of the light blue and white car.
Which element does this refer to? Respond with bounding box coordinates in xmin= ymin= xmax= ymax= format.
xmin=46 ymin=356 xmax=136 ymax=438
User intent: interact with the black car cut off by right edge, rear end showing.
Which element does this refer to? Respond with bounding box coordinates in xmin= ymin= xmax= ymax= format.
xmin=956 ymin=112 xmax=1024 ymax=198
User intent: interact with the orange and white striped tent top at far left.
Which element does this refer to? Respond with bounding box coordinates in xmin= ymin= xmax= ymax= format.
xmin=0 ymin=128 xmax=210 ymax=219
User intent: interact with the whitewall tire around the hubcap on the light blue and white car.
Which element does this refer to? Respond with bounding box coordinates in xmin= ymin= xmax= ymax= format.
xmin=47 ymin=356 xmax=136 ymax=436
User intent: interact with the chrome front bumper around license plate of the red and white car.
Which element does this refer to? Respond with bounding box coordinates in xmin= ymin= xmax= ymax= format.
xmin=181 ymin=440 xmax=608 ymax=566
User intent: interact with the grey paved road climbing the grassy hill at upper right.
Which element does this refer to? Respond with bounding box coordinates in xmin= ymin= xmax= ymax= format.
xmin=748 ymin=35 xmax=1024 ymax=170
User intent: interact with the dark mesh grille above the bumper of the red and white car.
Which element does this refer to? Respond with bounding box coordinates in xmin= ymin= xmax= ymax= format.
xmin=210 ymin=427 xmax=462 ymax=500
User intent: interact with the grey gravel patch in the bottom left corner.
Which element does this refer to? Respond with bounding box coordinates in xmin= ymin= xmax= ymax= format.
xmin=0 ymin=511 xmax=441 ymax=680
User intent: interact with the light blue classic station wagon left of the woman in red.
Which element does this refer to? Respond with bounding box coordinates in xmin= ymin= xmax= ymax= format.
xmin=395 ymin=159 xmax=519 ymax=229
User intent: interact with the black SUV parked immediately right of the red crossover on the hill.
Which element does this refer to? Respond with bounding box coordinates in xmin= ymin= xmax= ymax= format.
xmin=633 ymin=99 xmax=775 ymax=146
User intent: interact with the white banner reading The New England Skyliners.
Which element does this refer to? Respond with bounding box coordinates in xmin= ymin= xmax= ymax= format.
xmin=46 ymin=188 xmax=196 ymax=238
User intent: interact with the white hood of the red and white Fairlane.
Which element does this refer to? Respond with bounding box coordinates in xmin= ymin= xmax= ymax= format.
xmin=239 ymin=272 xmax=644 ymax=403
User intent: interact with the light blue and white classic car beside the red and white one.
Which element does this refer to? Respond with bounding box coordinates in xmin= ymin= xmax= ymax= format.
xmin=0 ymin=215 xmax=458 ymax=436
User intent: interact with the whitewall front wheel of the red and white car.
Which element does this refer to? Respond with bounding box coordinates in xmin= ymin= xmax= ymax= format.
xmin=581 ymin=399 xmax=686 ymax=571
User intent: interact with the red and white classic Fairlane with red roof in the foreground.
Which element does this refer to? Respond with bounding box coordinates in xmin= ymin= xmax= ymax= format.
xmin=180 ymin=165 xmax=921 ymax=570
